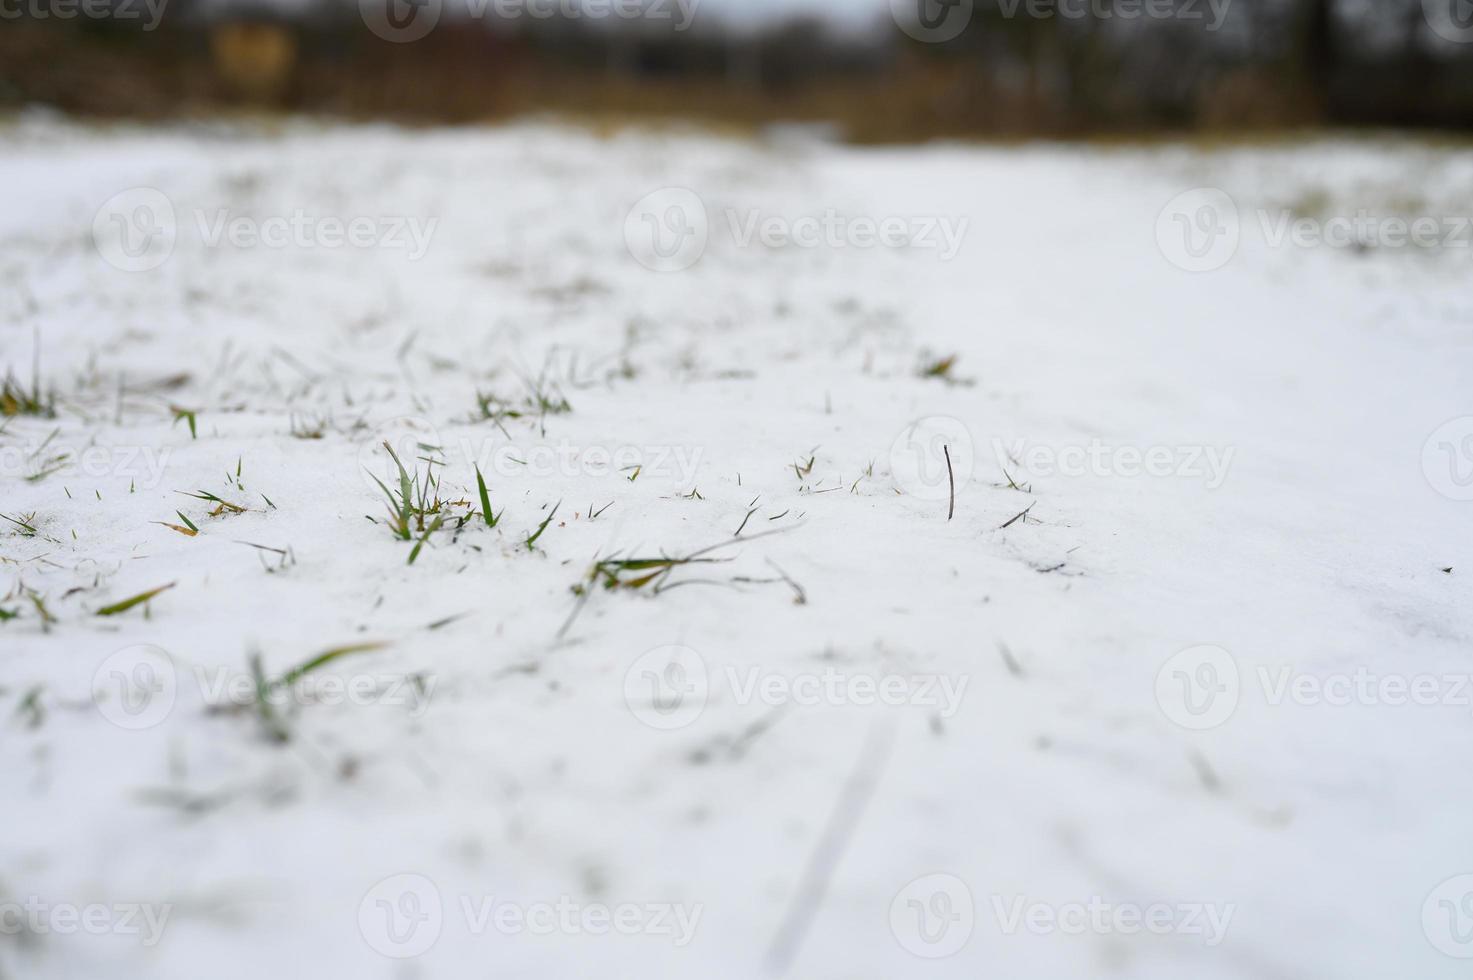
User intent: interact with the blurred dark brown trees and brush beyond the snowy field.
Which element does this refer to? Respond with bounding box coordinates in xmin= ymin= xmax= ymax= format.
xmin=0 ymin=0 xmax=1473 ymax=141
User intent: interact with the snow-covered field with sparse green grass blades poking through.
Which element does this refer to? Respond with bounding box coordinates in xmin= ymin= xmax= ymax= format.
xmin=0 ymin=118 xmax=1473 ymax=980
